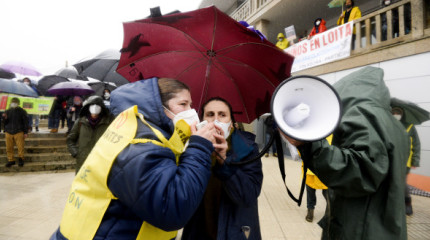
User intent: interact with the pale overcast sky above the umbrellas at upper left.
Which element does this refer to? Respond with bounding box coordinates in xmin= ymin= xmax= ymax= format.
xmin=0 ymin=0 xmax=201 ymax=75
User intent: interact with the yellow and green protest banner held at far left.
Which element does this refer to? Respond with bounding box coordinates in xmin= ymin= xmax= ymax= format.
xmin=0 ymin=93 xmax=54 ymax=115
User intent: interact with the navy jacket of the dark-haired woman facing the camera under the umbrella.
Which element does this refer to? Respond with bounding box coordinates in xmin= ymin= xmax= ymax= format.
xmin=182 ymin=130 xmax=263 ymax=240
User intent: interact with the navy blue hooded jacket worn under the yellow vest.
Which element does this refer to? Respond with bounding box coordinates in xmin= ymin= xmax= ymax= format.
xmin=51 ymin=78 xmax=214 ymax=239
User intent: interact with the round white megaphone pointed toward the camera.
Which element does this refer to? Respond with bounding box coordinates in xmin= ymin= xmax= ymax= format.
xmin=271 ymin=75 xmax=342 ymax=141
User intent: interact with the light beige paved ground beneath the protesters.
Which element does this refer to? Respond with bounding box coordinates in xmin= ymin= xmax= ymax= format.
xmin=0 ymin=157 xmax=430 ymax=240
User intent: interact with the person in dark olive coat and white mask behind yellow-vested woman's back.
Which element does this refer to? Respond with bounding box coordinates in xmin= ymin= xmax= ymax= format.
xmin=67 ymin=96 xmax=113 ymax=173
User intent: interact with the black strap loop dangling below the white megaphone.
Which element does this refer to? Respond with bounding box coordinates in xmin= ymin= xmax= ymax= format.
xmin=274 ymin=131 xmax=308 ymax=207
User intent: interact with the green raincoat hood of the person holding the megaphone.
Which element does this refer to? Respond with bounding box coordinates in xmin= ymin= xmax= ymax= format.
xmin=333 ymin=67 xmax=391 ymax=111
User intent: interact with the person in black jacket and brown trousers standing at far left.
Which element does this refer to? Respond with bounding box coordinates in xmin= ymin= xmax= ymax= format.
xmin=3 ymin=98 xmax=28 ymax=167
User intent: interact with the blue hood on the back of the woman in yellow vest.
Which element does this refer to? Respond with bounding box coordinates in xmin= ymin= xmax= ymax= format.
xmin=110 ymin=77 xmax=173 ymax=132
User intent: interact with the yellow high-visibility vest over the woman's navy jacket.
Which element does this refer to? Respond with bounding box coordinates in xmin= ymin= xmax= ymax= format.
xmin=60 ymin=106 xmax=191 ymax=240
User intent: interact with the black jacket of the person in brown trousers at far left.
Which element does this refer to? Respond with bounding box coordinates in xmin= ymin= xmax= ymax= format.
xmin=4 ymin=107 xmax=28 ymax=134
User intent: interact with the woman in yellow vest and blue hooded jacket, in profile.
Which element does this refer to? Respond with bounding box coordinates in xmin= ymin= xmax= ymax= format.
xmin=51 ymin=78 xmax=225 ymax=240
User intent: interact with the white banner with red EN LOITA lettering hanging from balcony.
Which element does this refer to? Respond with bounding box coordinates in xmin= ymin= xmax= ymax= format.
xmin=284 ymin=22 xmax=354 ymax=73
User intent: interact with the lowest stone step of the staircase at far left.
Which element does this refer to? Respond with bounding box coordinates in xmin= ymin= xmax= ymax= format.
xmin=0 ymin=160 xmax=76 ymax=172
